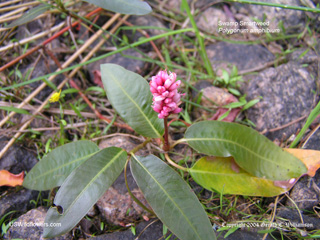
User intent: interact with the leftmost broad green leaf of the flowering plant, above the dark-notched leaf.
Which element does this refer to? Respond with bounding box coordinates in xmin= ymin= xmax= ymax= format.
xmin=23 ymin=140 xmax=100 ymax=191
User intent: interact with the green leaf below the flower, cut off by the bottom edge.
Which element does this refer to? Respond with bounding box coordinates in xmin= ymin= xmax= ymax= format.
xmin=130 ymin=155 xmax=216 ymax=240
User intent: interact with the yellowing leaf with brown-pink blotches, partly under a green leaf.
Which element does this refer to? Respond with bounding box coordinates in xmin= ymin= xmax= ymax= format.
xmin=189 ymin=157 xmax=294 ymax=197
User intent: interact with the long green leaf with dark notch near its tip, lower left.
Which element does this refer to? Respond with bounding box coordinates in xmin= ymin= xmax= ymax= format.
xmin=43 ymin=147 xmax=127 ymax=238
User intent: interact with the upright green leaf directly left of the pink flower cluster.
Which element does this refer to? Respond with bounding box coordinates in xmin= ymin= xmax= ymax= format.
xmin=101 ymin=64 xmax=164 ymax=138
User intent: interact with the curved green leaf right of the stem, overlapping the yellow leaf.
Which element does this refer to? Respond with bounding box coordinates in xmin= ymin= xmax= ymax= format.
xmin=185 ymin=121 xmax=307 ymax=181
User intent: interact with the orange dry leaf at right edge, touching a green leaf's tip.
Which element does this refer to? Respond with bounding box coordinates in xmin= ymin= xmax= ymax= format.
xmin=284 ymin=148 xmax=320 ymax=177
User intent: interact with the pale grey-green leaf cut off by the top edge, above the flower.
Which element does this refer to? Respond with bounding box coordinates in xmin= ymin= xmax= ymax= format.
xmin=84 ymin=0 xmax=152 ymax=15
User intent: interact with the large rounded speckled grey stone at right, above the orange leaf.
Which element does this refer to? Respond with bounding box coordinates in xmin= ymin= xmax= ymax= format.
xmin=245 ymin=50 xmax=318 ymax=140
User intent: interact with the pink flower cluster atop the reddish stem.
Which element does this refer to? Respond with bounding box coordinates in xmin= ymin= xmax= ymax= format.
xmin=150 ymin=70 xmax=181 ymax=118
